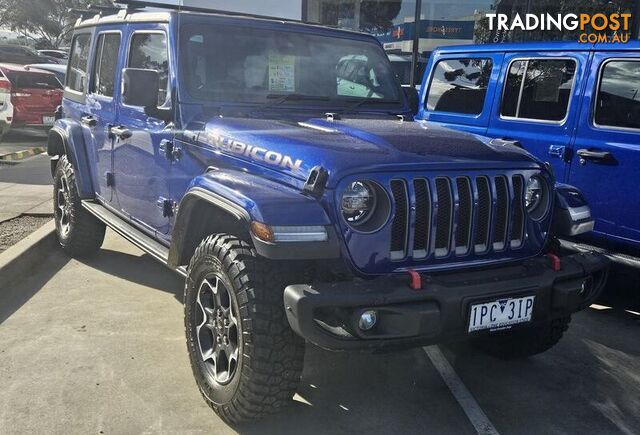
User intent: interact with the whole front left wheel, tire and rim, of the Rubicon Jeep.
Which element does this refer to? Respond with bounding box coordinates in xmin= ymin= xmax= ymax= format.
xmin=184 ymin=235 xmax=304 ymax=423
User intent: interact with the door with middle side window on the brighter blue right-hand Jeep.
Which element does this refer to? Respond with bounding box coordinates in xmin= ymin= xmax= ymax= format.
xmin=487 ymin=52 xmax=589 ymax=180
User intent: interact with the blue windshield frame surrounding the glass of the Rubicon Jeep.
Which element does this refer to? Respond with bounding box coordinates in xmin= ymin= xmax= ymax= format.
xmin=174 ymin=13 xmax=411 ymax=114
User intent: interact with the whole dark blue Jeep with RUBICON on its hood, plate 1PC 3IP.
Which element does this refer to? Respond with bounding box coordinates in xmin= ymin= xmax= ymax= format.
xmin=48 ymin=2 xmax=607 ymax=422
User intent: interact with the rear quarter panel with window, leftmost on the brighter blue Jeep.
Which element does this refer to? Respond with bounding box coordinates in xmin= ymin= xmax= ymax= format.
xmin=418 ymin=52 xmax=502 ymax=134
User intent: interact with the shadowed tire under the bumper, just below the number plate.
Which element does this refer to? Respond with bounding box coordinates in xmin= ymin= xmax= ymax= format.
xmin=474 ymin=316 xmax=571 ymax=359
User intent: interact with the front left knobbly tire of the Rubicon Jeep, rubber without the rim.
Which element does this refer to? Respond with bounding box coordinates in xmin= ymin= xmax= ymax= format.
xmin=184 ymin=234 xmax=304 ymax=424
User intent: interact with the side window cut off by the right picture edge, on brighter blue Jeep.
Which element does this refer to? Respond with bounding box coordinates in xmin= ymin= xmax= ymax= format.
xmin=594 ymin=59 xmax=640 ymax=129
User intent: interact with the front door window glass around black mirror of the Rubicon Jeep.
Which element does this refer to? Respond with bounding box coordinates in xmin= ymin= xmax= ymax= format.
xmin=128 ymin=33 xmax=169 ymax=106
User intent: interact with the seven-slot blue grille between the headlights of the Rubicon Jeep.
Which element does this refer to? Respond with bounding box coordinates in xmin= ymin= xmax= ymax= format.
xmin=390 ymin=175 xmax=526 ymax=260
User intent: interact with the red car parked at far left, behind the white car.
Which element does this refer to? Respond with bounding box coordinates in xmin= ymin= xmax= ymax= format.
xmin=0 ymin=63 xmax=62 ymax=127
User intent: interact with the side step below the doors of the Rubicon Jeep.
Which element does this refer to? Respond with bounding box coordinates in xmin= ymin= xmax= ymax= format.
xmin=82 ymin=201 xmax=187 ymax=277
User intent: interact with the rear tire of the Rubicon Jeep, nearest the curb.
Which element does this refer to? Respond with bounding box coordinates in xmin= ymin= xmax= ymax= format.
xmin=53 ymin=155 xmax=106 ymax=257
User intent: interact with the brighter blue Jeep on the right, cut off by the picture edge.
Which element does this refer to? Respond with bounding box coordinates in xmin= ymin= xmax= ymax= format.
xmin=418 ymin=41 xmax=640 ymax=265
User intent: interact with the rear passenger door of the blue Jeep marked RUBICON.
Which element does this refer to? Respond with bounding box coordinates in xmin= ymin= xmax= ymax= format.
xmin=80 ymin=29 xmax=122 ymax=204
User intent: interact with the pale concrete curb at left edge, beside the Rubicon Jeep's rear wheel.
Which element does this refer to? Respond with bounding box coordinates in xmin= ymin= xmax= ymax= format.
xmin=0 ymin=220 xmax=56 ymax=288
